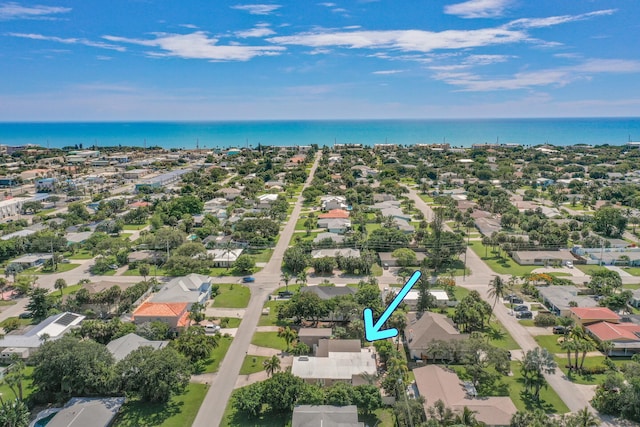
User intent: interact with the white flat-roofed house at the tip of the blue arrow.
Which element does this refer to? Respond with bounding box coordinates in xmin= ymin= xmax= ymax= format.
xmin=291 ymin=347 xmax=377 ymax=386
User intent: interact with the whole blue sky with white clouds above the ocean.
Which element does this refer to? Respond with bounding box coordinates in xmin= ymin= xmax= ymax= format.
xmin=0 ymin=0 xmax=640 ymax=121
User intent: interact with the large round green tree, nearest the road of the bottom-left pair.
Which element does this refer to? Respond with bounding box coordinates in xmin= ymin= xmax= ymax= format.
xmin=115 ymin=347 xmax=191 ymax=402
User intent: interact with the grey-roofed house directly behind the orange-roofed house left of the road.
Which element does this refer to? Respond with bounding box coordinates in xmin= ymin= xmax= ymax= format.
xmin=149 ymin=273 xmax=211 ymax=309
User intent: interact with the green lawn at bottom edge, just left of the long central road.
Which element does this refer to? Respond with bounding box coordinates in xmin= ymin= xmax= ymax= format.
xmin=113 ymin=383 xmax=208 ymax=427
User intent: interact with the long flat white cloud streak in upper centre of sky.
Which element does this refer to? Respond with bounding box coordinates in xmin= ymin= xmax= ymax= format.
xmin=267 ymin=28 xmax=528 ymax=52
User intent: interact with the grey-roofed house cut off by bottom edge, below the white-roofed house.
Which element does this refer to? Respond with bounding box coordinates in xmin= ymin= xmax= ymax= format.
xmin=291 ymin=405 xmax=364 ymax=427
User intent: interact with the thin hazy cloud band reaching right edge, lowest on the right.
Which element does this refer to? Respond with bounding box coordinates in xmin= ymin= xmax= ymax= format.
xmin=434 ymin=59 xmax=640 ymax=92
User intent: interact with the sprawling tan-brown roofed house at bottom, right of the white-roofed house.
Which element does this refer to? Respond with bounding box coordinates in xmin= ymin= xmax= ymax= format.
xmin=413 ymin=365 xmax=517 ymax=427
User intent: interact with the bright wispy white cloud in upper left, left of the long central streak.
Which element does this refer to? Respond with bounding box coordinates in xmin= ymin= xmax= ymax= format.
xmin=104 ymin=31 xmax=286 ymax=61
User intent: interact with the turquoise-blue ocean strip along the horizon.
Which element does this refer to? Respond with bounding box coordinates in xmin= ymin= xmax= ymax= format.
xmin=0 ymin=117 xmax=640 ymax=148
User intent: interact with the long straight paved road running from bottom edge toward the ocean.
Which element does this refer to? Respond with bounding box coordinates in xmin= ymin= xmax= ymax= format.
xmin=193 ymin=153 xmax=321 ymax=427
